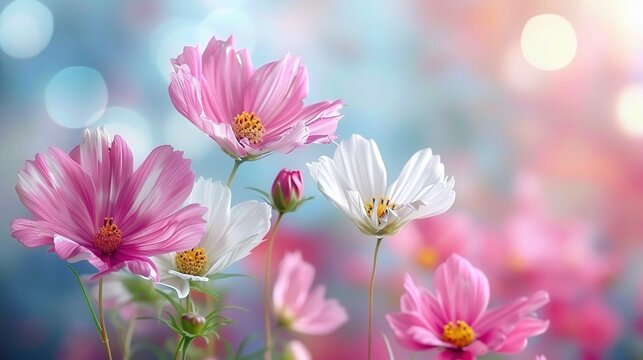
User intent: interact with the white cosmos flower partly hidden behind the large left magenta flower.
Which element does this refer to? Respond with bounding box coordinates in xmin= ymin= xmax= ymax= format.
xmin=153 ymin=178 xmax=272 ymax=298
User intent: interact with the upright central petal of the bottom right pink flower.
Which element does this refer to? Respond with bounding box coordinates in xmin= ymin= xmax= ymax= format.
xmin=434 ymin=254 xmax=489 ymax=325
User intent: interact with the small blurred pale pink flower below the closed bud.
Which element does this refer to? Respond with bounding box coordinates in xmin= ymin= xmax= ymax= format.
xmin=272 ymin=252 xmax=348 ymax=335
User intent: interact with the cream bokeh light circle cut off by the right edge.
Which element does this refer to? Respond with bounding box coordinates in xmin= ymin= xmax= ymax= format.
xmin=616 ymin=85 xmax=643 ymax=137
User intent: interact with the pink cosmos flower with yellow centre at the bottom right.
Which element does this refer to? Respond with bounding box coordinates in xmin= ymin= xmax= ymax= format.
xmin=387 ymin=254 xmax=549 ymax=360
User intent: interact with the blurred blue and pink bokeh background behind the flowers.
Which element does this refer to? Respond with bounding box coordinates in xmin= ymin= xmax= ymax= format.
xmin=0 ymin=0 xmax=643 ymax=359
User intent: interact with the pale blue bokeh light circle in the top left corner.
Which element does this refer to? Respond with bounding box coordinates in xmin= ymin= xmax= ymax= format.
xmin=0 ymin=0 xmax=54 ymax=59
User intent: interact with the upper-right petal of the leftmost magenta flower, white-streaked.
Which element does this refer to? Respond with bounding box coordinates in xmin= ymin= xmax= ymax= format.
xmin=114 ymin=145 xmax=194 ymax=237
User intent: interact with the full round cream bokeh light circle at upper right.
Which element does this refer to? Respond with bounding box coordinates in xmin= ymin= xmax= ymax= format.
xmin=520 ymin=14 xmax=577 ymax=71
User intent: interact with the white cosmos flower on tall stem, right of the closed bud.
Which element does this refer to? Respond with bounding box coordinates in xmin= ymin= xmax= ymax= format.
xmin=306 ymin=135 xmax=455 ymax=237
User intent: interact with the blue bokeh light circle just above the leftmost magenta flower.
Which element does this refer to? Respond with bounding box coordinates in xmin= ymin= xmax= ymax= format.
xmin=45 ymin=66 xmax=107 ymax=128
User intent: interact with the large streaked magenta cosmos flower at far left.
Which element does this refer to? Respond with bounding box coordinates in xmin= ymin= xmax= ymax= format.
xmin=11 ymin=129 xmax=206 ymax=279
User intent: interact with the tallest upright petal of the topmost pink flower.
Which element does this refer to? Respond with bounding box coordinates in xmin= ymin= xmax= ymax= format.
xmin=200 ymin=36 xmax=254 ymax=124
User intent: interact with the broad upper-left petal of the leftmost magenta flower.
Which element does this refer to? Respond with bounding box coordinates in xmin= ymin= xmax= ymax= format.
xmin=13 ymin=148 xmax=96 ymax=246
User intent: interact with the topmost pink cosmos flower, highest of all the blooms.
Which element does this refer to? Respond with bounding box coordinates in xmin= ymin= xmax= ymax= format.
xmin=169 ymin=36 xmax=342 ymax=160
